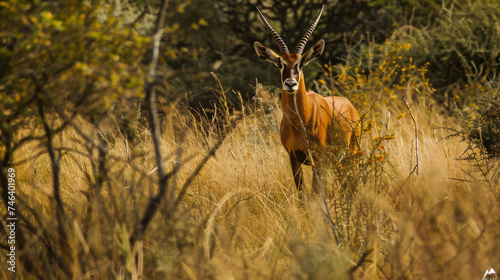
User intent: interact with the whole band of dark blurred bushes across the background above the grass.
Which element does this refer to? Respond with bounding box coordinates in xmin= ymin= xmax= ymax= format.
xmin=0 ymin=0 xmax=500 ymax=120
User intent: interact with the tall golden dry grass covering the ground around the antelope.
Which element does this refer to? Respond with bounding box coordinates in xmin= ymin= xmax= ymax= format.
xmin=1 ymin=80 xmax=500 ymax=279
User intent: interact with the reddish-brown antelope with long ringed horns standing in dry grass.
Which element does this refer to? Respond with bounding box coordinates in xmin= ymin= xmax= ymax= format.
xmin=254 ymin=6 xmax=361 ymax=194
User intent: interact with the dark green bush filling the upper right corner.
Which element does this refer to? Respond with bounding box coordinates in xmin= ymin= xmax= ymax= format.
xmin=394 ymin=0 xmax=500 ymax=105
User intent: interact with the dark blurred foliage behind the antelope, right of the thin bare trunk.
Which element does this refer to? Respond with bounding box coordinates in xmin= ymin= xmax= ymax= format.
xmin=157 ymin=0 xmax=500 ymax=109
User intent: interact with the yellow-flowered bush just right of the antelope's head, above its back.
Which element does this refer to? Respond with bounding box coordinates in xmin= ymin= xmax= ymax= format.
xmin=324 ymin=41 xmax=433 ymax=111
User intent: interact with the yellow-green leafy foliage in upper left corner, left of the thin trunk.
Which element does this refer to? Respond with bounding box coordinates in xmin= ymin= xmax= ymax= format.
xmin=0 ymin=0 xmax=150 ymax=165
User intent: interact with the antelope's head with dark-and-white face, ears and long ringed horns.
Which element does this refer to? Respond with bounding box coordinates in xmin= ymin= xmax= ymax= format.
xmin=253 ymin=6 xmax=325 ymax=94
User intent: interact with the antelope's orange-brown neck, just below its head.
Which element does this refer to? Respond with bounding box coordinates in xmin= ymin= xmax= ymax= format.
xmin=281 ymin=73 xmax=310 ymax=124
